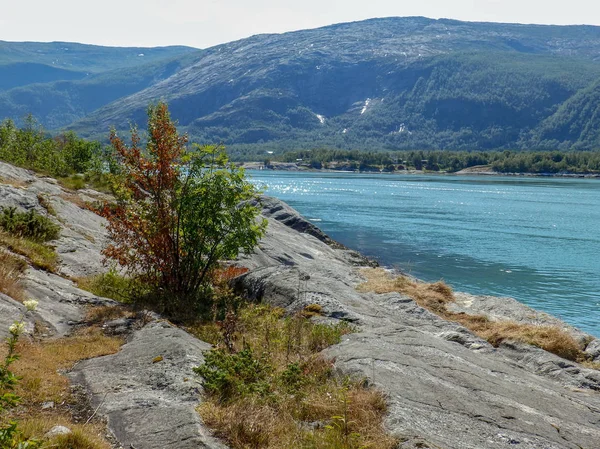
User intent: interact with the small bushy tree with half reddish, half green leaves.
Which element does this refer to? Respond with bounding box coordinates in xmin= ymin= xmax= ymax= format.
xmin=101 ymin=103 xmax=266 ymax=313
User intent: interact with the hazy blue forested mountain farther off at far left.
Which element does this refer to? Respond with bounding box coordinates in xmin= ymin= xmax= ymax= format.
xmin=0 ymin=41 xmax=199 ymax=130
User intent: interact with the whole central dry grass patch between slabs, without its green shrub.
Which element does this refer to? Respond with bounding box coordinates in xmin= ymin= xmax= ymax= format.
xmin=192 ymin=306 xmax=398 ymax=449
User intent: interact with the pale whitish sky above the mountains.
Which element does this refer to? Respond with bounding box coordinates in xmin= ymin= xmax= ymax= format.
xmin=0 ymin=0 xmax=600 ymax=48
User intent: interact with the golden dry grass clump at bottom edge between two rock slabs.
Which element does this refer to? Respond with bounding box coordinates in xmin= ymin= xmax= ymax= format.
xmin=198 ymin=382 xmax=398 ymax=449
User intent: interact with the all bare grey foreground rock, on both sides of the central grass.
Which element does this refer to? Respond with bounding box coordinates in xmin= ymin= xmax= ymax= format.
xmin=0 ymin=163 xmax=600 ymax=449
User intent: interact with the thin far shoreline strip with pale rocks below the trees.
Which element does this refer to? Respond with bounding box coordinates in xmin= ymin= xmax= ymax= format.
xmin=241 ymin=162 xmax=600 ymax=179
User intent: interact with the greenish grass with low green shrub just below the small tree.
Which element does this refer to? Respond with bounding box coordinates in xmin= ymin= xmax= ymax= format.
xmin=192 ymin=306 xmax=353 ymax=402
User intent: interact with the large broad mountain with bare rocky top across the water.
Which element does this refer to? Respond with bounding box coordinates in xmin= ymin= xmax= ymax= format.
xmin=0 ymin=17 xmax=600 ymax=154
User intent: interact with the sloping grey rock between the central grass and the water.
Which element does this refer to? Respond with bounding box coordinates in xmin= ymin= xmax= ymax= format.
xmin=237 ymin=196 xmax=600 ymax=449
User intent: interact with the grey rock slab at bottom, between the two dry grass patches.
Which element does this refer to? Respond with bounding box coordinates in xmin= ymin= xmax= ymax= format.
xmin=70 ymin=322 xmax=225 ymax=449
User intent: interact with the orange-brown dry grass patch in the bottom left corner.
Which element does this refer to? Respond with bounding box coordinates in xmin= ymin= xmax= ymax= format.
xmin=0 ymin=327 xmax=123 ymax=449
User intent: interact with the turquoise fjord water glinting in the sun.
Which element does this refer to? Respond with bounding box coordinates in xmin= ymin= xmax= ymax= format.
xmin=248 ymin=171 xmax=600 ymax=336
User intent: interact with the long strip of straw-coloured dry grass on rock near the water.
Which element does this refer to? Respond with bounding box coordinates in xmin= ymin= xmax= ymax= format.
xmin=357 ymin=268 xmax=585 ymax=361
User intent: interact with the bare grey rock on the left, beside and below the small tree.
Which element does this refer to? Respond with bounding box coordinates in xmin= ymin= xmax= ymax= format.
xmin=0 ymin=162 xmax=225 ymax=449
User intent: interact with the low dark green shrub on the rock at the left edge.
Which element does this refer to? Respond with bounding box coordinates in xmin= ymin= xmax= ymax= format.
xmin=0 ymin=207 xmax=60 ymax=243
